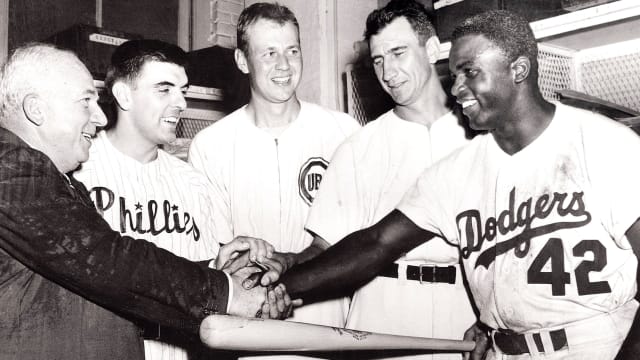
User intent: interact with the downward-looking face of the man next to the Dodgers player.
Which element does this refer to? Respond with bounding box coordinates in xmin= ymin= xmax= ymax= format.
xmin=369 ymin=17 xmax=432 ymax=106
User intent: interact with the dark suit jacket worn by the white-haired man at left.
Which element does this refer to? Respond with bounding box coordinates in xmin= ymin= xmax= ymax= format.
xmin=0 ymin=128 xmax=229 ymax=360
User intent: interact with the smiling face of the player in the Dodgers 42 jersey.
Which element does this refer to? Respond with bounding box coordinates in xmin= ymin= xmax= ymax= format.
xmin=449 ymin=35 xmax=516 ymax=130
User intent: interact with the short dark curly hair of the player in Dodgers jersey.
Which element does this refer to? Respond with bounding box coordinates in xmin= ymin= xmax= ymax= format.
xmin=451 ymin=10 xmax=538 ymax=69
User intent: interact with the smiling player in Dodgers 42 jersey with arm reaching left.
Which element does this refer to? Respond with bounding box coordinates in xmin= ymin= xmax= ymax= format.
xmin=282 ymin=11 xmax=640 ymax=359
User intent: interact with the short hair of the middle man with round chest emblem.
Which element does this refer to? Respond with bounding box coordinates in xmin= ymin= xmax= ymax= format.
xmin=237 ymin=2 xmax=300 ymax=54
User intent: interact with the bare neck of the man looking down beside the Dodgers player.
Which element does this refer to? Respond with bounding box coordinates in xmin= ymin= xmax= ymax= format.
xmin=393 ymin=81 xmax=451 ymax=128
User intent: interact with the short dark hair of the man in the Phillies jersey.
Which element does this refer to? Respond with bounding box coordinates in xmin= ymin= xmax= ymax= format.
xmin=104 ymin=39 xmax=187 ymax=94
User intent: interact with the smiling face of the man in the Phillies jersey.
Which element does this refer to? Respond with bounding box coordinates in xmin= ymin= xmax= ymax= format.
xmin=129 ymin=61 xmax=188 ymax=146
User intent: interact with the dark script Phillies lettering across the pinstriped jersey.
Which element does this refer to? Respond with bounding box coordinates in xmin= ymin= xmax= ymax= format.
xmin=90 ymin=186 xmax=200 ymax=241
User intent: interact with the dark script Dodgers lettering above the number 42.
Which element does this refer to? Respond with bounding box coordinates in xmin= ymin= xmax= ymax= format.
xmin=456 ymin=187 xmax=591 ymax=268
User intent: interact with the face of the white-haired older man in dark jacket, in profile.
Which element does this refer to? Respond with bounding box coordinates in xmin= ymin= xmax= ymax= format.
xmin=41 ymin=58 xmax=106 ymax=173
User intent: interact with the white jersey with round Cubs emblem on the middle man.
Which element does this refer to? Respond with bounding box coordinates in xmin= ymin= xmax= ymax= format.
xmin=189 ymin=101 xmax=359 ymax=326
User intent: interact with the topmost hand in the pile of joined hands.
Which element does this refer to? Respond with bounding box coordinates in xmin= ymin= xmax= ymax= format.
xmin=216 ymin=236 xmax=275 ymax=274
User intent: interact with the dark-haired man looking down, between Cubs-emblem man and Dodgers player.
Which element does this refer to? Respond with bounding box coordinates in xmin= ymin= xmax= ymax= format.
xmin=306 ymin=0 xmax=476 ymax=359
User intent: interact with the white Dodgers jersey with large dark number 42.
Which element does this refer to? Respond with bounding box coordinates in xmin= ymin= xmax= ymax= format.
xmin=398 ymin=104 xmax=640 ymax=334
